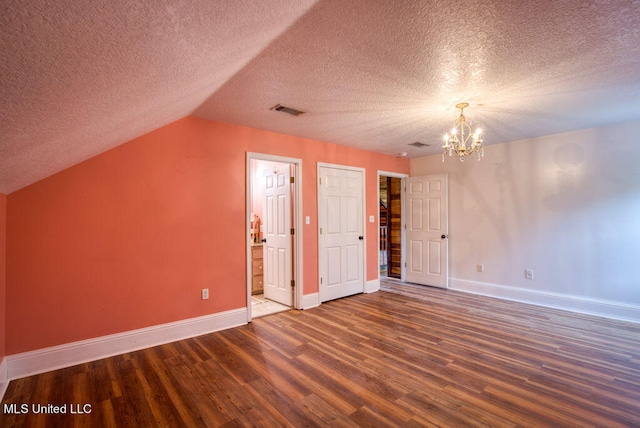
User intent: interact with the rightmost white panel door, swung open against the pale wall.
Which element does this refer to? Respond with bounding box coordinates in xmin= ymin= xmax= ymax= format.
xmin=405 ymin=174 xmax=449 ymax=288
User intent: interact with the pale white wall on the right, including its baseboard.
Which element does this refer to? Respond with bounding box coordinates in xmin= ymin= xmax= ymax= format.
xmin=411 ymin=122 xmax=640 ymax=321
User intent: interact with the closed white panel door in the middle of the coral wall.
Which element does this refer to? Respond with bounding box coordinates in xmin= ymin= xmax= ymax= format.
xmin=318 ymin=166 xmax=364 ymax=302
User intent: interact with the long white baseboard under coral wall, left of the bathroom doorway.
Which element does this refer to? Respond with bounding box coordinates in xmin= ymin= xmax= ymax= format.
xmin=6 ymin=308 xmax=247 ymax=380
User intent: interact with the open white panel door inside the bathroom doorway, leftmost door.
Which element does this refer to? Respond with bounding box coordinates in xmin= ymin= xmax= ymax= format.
xmin=263 ymin=165 xmax=293 ymax=306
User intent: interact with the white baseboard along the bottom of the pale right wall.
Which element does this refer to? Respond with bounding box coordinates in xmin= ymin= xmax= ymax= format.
xmin=449 ymin=278 xmax=640 ymax=322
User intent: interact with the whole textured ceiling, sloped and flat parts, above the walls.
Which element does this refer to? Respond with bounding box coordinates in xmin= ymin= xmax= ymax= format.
xmin=0 ymin=0 xmax=640 ymax=193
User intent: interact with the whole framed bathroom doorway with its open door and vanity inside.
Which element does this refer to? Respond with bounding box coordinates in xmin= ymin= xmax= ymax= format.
xmin=246 ymin=153 xmax=302 ymax=321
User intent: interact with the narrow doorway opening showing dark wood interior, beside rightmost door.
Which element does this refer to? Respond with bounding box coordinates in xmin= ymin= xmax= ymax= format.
xmin=378 ymin=171 xmax=406 ymax=280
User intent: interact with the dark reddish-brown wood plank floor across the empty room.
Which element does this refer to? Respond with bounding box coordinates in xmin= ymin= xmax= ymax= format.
xmin=0 ymin=282 xmax=640 ymax=427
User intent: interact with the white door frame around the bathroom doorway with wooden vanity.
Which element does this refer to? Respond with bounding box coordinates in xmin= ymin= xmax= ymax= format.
xmin=245 ymin=152 xmax=303 ymax=322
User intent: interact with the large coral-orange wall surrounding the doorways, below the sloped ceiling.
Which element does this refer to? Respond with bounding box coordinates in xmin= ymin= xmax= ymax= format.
xmin=6 ymin=117 xmax=409 ymax=355
